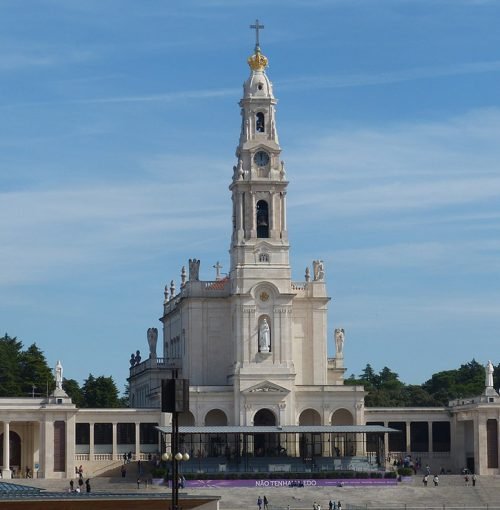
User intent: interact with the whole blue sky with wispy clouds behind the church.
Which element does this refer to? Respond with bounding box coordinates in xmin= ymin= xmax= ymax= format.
xmin=0 ymin=0 xmax=500 ymax=388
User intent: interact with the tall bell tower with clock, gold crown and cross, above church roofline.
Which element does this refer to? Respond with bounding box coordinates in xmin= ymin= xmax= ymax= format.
xmin=229 ymin=21 xmax=290 ymax=293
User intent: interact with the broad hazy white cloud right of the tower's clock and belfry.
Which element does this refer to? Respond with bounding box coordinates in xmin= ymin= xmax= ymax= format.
xmin=287 ymin=108 xmax=500 ymax=215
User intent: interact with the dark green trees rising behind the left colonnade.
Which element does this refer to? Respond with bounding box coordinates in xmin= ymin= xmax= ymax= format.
xmin=0 ymin=333 xmax=128 ymax=408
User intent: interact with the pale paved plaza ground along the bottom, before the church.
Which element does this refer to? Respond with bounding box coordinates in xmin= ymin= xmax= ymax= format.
xmin=5 ymin=475 xmax=500 ymax=510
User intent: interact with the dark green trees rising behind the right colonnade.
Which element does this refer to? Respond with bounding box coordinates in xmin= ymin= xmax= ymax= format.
xmin=344 ymin=359 xmax=500 ymax=407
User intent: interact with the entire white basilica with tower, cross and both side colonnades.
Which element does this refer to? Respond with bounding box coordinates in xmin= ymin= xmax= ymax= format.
xmin=0 ymin=30 xmax=500 ymax=478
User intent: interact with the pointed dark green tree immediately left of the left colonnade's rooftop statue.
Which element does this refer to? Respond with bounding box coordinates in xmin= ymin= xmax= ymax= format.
xmin=19 ymin=344 xmax=54 ymax=396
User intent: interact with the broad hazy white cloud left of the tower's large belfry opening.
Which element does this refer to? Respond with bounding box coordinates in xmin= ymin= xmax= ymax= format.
xmin=0 ymin=172 xmax=227 ymax=285
